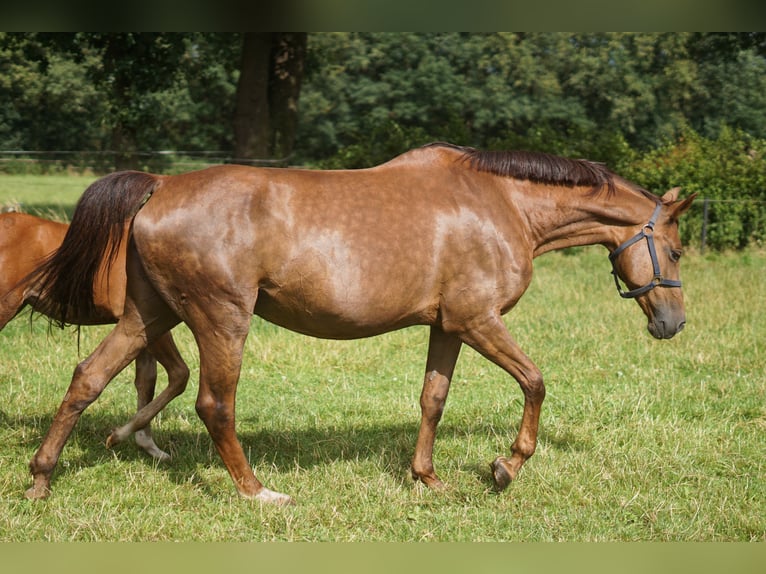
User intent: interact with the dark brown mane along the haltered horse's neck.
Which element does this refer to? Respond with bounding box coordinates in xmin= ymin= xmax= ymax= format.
xmin=424 ymin=142 xmax=657 ymax=200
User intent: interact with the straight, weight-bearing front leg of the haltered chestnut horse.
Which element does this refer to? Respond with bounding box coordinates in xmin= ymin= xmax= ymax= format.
xmin=411 ymin=326 xmax=462 ymax=488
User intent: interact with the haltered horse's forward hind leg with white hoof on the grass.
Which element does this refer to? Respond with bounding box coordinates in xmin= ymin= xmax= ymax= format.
xmin=190 ymin=308 xmax=291 ymax=504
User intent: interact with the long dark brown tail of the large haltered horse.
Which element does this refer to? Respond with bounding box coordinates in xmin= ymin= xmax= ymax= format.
xmin=29 ymin=171 xmax=159 ymax=327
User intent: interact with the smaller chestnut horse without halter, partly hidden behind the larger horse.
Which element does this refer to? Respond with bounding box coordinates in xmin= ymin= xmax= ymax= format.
xmin=0 ymin=212 xmax=189 ymax=460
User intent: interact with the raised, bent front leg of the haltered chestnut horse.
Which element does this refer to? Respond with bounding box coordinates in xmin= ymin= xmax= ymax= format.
xmin=461 ymin=315 xmax=545 ymax=490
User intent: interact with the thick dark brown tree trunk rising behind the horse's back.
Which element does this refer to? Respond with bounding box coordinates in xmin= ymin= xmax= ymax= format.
xmin=234 ymin=32 xmax=307 ymax=163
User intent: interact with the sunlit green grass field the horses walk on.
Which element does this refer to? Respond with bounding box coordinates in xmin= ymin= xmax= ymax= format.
xmin=0 ymin=176 xmax=766 ymax=542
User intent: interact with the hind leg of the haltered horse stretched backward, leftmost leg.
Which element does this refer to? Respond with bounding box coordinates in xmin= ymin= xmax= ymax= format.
xmin=26 ymin=322 xmax=152 ymax=499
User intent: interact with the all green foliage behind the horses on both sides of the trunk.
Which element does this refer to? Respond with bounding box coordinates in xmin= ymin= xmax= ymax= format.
xmin=0 ymin=32 xmax=766 ymax=248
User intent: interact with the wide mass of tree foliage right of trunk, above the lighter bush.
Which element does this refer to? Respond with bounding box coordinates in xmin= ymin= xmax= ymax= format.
xmin=297 ymin=32 xmax=766 ymax=167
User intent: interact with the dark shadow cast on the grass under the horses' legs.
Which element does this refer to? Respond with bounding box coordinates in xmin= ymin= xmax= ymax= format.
xmin=0 ymin=409 xmax=588 ymax=498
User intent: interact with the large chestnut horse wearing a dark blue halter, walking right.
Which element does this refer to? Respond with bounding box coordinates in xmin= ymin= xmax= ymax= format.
xmin=22 ymin=143 xmax=693 ymax=504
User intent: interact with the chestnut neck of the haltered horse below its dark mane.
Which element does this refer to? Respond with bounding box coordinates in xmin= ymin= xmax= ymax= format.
xmin=514 ymin=188 xmax=654 ymax=257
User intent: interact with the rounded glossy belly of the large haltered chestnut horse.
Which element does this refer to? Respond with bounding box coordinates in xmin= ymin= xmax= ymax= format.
xmin=254 ymin=231 xmax=438 ymax=339
